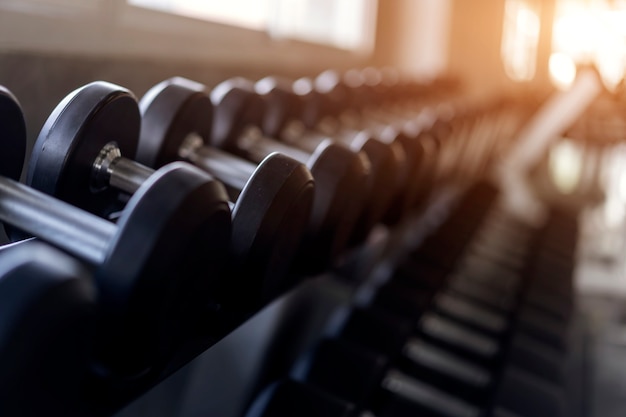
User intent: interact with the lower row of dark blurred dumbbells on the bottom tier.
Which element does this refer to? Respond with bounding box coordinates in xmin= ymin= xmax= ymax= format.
xmin=245 ymin=185 xmax=578 ymax=417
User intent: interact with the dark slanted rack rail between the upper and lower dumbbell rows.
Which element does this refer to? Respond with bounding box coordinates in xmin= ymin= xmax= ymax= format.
xmin=109 ymin=180 xmax=587 ymax=417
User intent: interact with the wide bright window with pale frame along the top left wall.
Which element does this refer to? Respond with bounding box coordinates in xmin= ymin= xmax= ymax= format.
xmin=0 ymin=0 xmax=377 ymax=72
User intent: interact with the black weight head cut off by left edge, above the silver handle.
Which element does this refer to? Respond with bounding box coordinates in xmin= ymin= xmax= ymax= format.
xmin=0 ymin=86 xmax=26 ymax=180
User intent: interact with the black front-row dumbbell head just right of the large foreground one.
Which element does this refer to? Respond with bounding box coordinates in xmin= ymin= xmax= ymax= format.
xmin=232 ymin=153 xmax=314 ymax=303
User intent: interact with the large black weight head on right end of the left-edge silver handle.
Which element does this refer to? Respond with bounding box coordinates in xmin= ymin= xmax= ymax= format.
xmin=96 ymin=162 xmax=231 ymax=372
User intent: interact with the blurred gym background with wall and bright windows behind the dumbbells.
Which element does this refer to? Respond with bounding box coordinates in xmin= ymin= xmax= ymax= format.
xmin=0 ymin=0 xmax=626 ymax=417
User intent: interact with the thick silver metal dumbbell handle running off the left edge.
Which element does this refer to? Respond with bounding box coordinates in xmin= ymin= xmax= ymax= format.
xmin=0 ymin=178 xmax=117 ymax=265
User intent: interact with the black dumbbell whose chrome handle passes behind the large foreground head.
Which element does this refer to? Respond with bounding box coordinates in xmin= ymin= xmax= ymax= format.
xmin=28 ymin=83 xmax=313 ymax=310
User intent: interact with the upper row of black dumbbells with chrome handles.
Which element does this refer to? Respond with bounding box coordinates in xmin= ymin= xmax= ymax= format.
xmin=0 ymin=66 xmax=528 ymax=415
